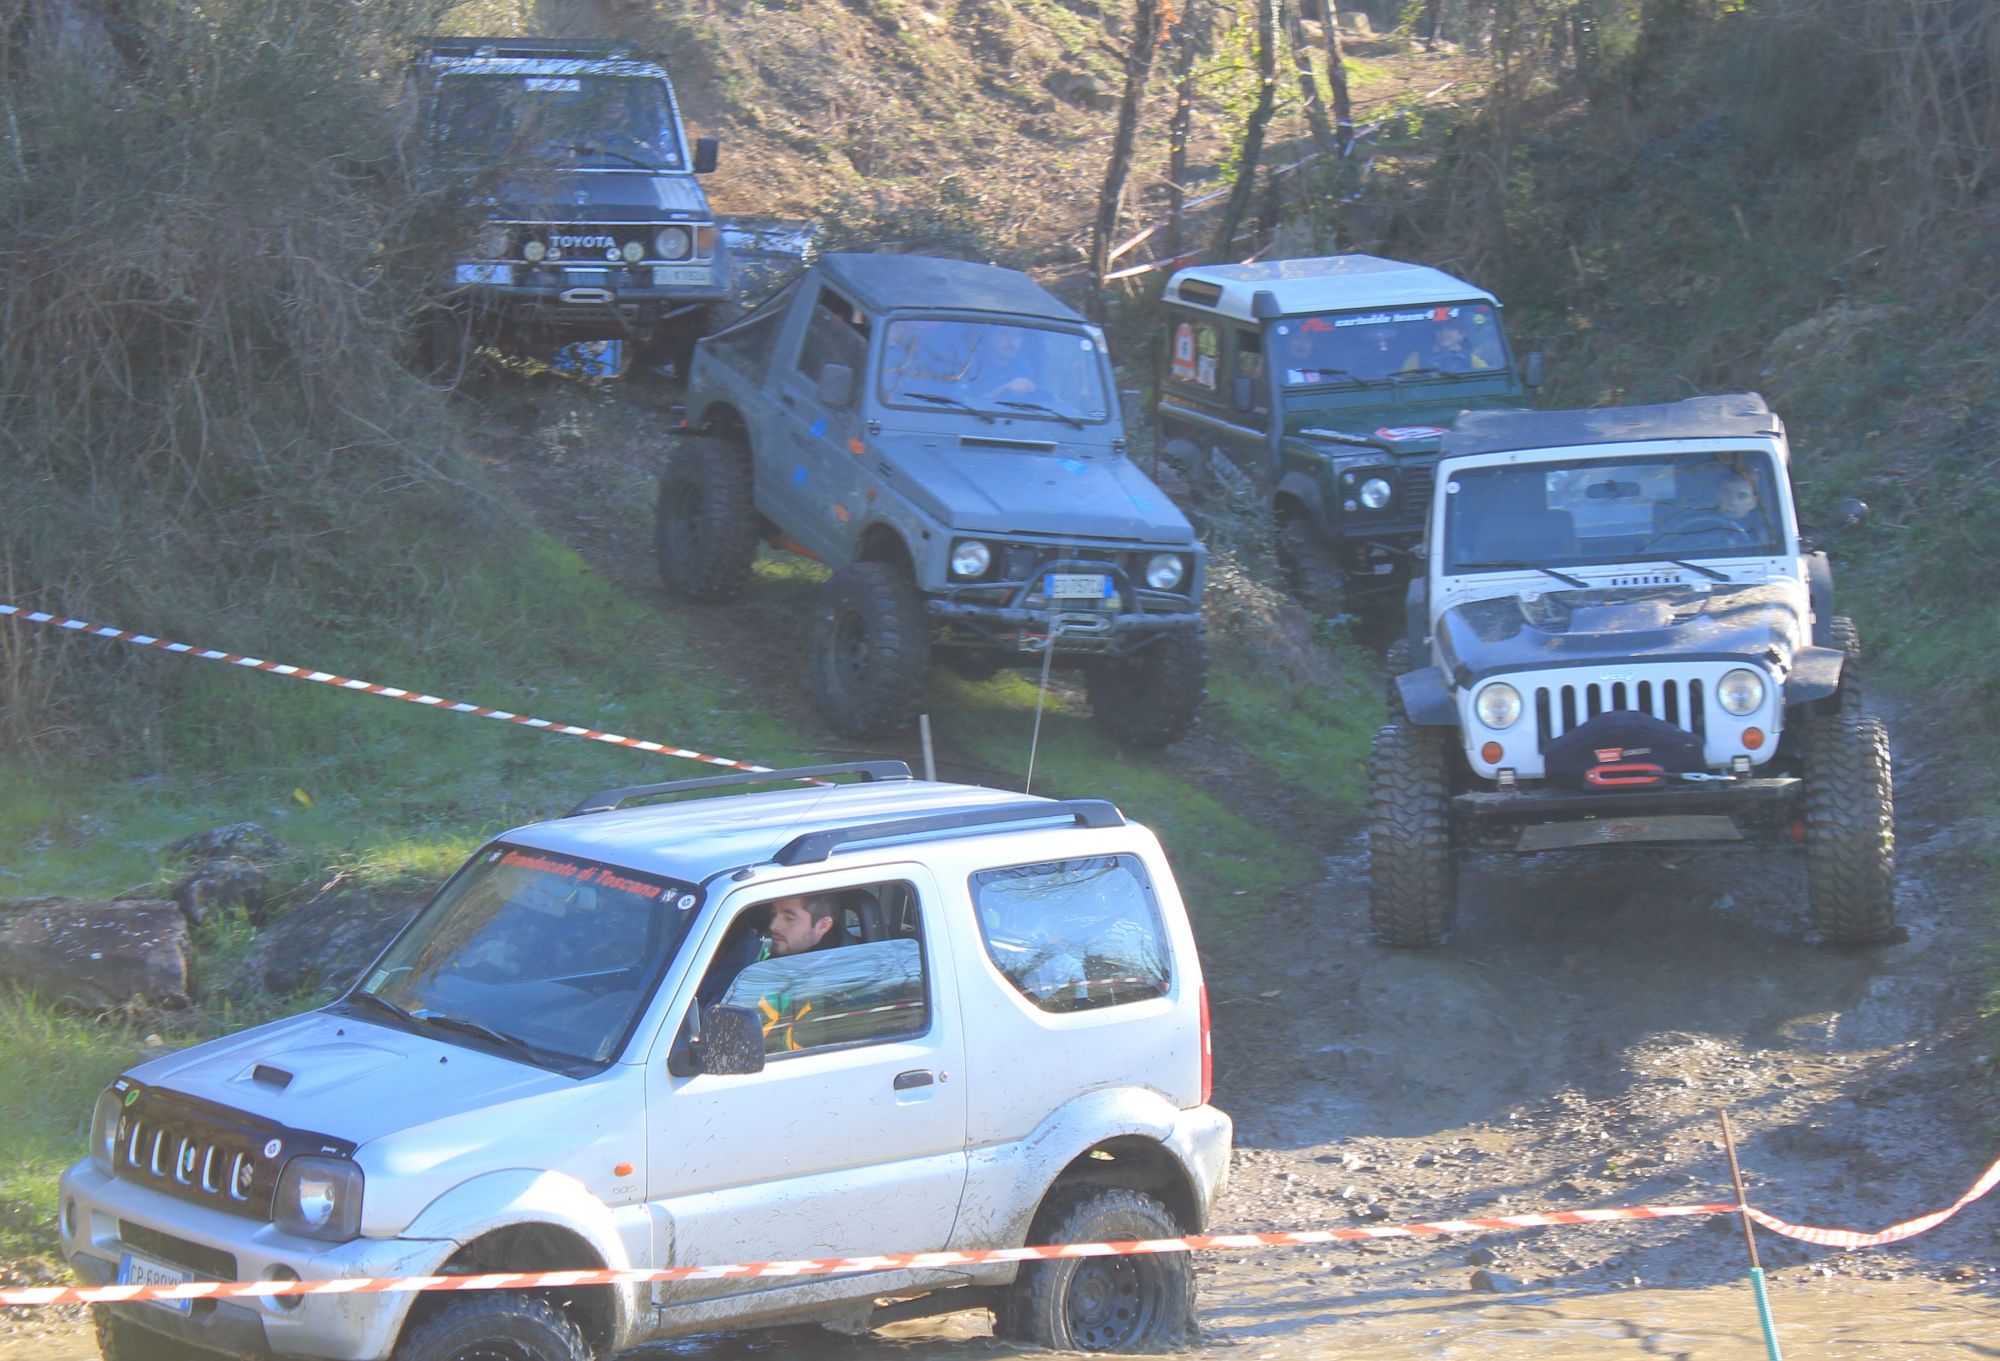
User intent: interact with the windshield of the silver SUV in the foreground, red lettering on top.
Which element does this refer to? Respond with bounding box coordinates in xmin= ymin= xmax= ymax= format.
xmin=340 ymin=845 xmax=698 ymax=1069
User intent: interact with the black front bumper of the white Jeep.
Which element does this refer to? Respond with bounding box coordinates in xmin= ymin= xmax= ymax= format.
xmin=1452 ymin=777 xmax=1806 ymax=851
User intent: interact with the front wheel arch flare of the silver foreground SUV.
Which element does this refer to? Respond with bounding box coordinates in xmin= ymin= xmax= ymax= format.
xmin=398 ymin=1167 xmax=652 ymax=1351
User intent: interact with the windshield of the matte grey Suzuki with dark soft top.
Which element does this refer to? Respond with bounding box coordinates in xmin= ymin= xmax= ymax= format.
xmin=878 ymin=316 xmax=1112 ymax=424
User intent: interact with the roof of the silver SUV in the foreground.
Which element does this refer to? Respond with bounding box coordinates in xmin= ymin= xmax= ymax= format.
xmin=504 ymin=763 xmax=1116 ymax=883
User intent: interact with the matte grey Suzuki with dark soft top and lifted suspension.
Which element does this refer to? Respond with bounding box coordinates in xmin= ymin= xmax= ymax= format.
xmin=656 ymin=254 xmax=1206 ymax=747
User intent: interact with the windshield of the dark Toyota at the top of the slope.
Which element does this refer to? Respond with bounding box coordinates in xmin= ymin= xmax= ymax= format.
xmin=432 ymin=74 xmax=684 ymax=170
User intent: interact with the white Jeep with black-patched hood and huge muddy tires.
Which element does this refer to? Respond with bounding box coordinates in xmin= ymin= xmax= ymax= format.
xmin=1368 ymin=394 xmax=1896 ymax=947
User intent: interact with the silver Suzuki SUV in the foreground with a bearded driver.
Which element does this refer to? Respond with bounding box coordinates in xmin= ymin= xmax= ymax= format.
xmin=62 ymin=761 xmax=1230 ymax=1361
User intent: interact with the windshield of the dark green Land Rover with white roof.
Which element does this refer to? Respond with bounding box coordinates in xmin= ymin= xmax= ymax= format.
xmin=1264 ymin=302 xmax=1508 ymax=388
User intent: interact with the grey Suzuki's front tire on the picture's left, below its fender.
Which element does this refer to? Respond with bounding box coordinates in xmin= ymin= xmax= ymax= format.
xmin=806 ymin=562 xmax=930 ymax=737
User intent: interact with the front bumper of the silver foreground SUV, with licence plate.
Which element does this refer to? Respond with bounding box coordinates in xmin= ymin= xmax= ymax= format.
xmin=60 ymin=1163 xmax=456 ymax=1361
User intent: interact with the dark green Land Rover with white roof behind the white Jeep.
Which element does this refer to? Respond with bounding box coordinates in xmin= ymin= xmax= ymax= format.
xmin=1158 ymin=254 xmax=1540 ymax=616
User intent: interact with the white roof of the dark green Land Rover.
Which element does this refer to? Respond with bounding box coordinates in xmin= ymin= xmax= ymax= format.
xmin=1166 ymin=254 xmax=1498 ymax=322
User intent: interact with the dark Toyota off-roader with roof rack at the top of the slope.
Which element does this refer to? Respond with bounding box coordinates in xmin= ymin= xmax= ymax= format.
xmin=410 ymin=38 xmax=730 ymax=368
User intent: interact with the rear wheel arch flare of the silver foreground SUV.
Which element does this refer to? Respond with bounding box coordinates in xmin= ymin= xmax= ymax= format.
xmin=952 ymin=1087 xmax=1228 ymax=1281
